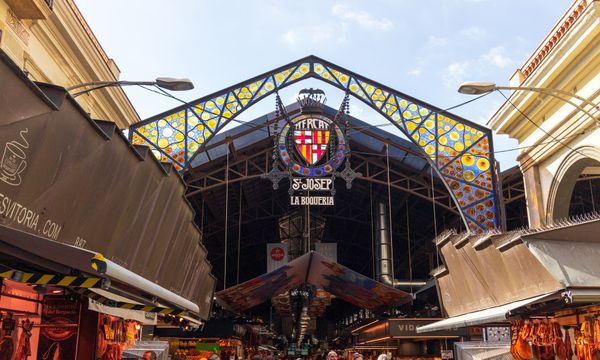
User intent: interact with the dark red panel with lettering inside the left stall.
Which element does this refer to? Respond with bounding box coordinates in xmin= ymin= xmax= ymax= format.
xmin=37 ymin=295 xmax=79 ymax=360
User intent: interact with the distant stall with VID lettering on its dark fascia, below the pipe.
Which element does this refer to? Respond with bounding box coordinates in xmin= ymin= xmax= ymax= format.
xmin=349 ymin=318 xmax=468 ymax=359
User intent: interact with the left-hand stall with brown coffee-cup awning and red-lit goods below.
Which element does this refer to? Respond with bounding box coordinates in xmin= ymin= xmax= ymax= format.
xmin=0 ymin=45 xmax=215 ymax=360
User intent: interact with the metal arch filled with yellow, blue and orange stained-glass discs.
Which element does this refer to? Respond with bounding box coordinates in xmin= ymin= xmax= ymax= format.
xmin=130 ymin=56 xmax=501 ymax=232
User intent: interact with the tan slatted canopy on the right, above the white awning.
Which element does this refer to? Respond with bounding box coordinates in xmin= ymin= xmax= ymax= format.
xmin=432 ymin=215 xmax=600 ymax=318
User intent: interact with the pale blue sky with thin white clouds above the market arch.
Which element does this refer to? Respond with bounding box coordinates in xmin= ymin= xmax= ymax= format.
xmin=75 ymin=0 xmax=571 ymax=170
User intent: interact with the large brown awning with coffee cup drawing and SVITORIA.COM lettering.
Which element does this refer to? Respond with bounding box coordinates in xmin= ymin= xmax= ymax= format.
xmin=0 ymin=50 xmax=215 ymax=319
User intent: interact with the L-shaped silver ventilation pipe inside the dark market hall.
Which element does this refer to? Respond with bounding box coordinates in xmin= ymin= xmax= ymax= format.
xmin=375 ymin=201 xmax=427 ymax=288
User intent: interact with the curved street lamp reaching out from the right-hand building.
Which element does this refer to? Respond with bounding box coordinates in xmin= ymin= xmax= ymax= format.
xmin=458 ymin=81 xmax=600 ymax=121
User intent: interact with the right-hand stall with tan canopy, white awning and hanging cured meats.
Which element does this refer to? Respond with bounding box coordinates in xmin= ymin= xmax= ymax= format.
xmin=417 ymin=216 xmax=600 ymax=359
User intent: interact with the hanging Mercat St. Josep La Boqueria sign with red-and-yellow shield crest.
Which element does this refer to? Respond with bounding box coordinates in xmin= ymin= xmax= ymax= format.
xmin=264 ymin=88 xmax=361 ymax=206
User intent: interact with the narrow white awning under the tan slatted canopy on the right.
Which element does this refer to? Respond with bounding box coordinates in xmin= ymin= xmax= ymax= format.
xmin=417 ymin=294 xmax=550 ymax=333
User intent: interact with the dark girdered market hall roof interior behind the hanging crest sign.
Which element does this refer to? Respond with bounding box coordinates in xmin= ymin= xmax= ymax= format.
xmin=185 ymin=104 xmax=464 ymax=296
